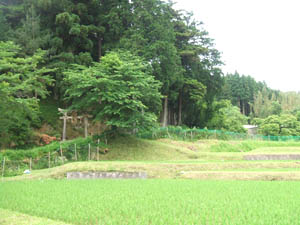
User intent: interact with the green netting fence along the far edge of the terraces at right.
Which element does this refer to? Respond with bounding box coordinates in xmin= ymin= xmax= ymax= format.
xmin=137 ymin=127 xmax=300 ymax=141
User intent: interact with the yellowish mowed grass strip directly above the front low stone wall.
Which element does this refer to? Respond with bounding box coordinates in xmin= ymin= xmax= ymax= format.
xmin=3 ymin=160 xmax=300 ymax=181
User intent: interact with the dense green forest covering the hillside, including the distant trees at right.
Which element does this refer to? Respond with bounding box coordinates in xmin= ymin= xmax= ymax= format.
xmin=0 ymin=0 xmax=300 ymax=148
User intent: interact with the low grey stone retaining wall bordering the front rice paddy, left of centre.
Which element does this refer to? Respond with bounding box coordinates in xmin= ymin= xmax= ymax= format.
xmin=67 ymin=172 xmax=147 ymax=179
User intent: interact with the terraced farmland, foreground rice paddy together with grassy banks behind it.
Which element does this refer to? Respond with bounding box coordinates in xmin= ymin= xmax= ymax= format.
xmin=0 ymin=139 xmax=300 ymax=225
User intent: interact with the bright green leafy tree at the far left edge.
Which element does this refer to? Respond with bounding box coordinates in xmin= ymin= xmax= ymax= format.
xmin=0 ymin=42 xmax=52 ymax=147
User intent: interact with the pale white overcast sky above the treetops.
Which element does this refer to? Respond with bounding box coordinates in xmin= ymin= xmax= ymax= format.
xmin=174 ymin=0 xmax=300 ymax=91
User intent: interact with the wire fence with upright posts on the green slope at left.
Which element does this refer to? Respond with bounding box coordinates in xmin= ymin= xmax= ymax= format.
xmin=0 ymin=138 xmax=107 ymax=177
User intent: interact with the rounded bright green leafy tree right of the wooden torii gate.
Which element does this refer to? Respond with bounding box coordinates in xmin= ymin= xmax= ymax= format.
xmin=64 ymin=51 xmax=162 ymax=134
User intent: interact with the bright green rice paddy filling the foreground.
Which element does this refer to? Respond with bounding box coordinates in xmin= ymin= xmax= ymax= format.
xmin=0 ymin=180 xmax=300 ymax=225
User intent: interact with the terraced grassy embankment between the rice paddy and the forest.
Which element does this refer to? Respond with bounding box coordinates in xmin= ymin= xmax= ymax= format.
xmin=4 ymin=137 xmax=300 ymax=180
